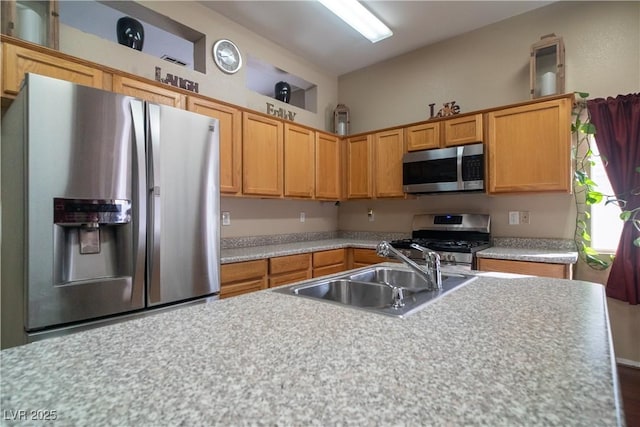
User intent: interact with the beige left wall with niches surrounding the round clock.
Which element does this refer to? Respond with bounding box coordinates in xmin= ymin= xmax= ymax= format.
xmin=60 ymin=1 xmax=338 ymax=130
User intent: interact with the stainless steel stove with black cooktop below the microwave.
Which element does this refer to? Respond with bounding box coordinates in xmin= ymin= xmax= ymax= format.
xmin=391 ymin=214 xmax=491 ymax=270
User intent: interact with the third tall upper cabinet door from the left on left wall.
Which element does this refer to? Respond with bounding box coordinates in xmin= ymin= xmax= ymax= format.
xmin=284 ymin=123 xmax=316 ymax=199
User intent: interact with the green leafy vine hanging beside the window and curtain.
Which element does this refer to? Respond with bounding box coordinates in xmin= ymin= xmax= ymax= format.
xmin=571 ymin=92 xmax=640 ymax=270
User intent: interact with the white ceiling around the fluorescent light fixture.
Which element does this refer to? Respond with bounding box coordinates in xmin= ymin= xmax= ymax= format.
xmin=200 ymin=0 xmax=553 ymax=76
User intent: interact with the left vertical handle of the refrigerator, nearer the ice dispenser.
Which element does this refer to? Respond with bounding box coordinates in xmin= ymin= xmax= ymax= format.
xmin=130 ymin=99 xmax=147 ymax=301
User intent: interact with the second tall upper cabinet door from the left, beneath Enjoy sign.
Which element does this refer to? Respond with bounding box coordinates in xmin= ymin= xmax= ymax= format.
xmin=242 ymin=112 xmax=283 ymax=196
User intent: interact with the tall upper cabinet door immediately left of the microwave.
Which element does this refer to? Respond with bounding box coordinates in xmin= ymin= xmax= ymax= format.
xmin=373 ymin=129 xmax=404 ymax=197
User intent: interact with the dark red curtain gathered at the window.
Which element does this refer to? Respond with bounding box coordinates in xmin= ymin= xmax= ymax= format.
xmin=587 ymin=93 xmax=640 ymax=304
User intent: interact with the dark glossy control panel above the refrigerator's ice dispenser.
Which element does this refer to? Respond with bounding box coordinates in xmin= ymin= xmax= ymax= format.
xmin=53 ymin=197 xmax=131 ymax=226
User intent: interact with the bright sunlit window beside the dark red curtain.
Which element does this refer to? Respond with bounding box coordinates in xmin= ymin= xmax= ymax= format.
xmin=590 ymin=142 xmax=623 ymax=253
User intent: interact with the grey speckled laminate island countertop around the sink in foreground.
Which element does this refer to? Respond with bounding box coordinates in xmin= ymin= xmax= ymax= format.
xmin=0 ymin=266 xmax=621 ymax=426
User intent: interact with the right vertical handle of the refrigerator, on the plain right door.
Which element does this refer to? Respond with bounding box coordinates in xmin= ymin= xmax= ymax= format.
xmin=147 ymin=103 xmax=162 ymax=303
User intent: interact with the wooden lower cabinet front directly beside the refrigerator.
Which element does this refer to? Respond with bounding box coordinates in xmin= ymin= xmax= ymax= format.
xmin=220 ymin=259 xmax=268 ymax=299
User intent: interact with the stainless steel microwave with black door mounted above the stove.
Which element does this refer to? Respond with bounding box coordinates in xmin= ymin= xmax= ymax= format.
xmin=402 ymin=143 xmax=484 ymax=194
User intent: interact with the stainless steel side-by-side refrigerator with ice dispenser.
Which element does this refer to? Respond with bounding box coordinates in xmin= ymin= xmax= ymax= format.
xmin=1 ymin=74 xmax=220 ymax=347
